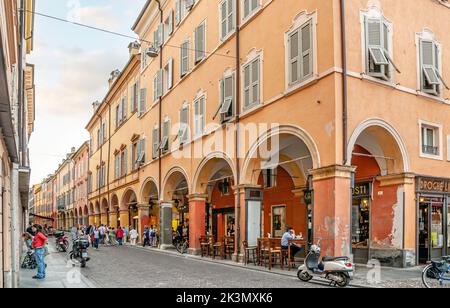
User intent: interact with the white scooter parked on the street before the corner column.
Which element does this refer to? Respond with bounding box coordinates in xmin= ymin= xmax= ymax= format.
xmin=297 ymin=243 xmax=355 ymax=288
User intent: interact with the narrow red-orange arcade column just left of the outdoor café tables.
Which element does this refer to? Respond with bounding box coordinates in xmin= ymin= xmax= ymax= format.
xmin=188 ymin=194 xmax=208 ymax=255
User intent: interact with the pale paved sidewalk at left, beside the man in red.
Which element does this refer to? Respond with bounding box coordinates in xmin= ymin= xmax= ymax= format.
xmin=20 ymin=238 xmax=96 ymax=289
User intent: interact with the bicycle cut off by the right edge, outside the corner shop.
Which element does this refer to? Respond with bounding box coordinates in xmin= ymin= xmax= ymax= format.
xmin=422 ymin=256 xmax=450 ymax=289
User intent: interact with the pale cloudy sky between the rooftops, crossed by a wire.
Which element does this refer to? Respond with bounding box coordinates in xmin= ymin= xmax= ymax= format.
xmin=28 ymin=0 xmax=145 ymax=184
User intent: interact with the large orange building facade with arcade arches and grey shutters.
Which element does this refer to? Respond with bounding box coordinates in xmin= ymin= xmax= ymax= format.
xmin=74 ymin=0 xmax=450 ymax=267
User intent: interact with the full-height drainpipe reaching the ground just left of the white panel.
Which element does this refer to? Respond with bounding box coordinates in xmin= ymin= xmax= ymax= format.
xmin=234 ymin=0 xmax=241 ymax=262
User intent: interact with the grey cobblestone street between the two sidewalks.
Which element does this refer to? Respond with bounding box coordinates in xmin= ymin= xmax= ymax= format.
xmin=82 ymin=247 xmax=324 ymax=288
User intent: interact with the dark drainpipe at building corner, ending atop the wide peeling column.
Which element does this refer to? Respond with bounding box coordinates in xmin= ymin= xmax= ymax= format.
xmin=341 ymin=0 xmax=348 ymax=166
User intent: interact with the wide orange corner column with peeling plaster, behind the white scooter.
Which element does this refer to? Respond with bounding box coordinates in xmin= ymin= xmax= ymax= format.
xmin=312 ymin=165 xmax=355 ymax=257
